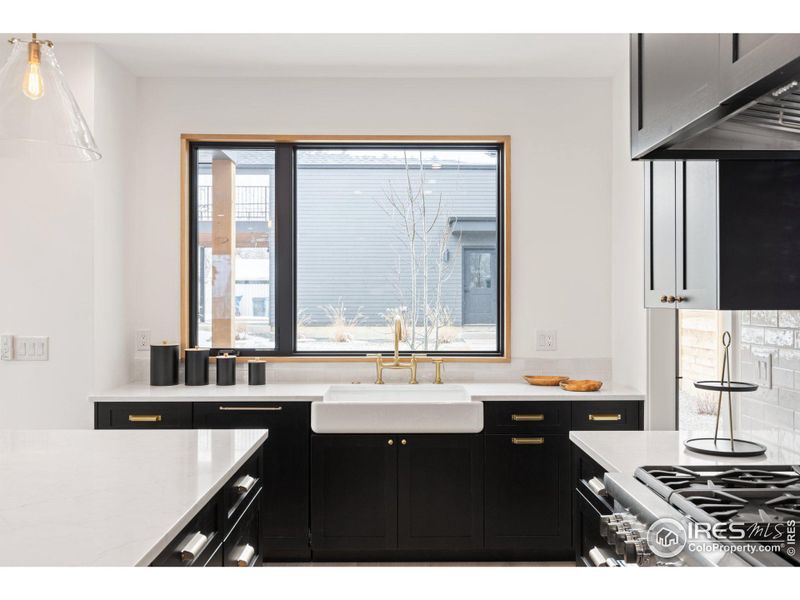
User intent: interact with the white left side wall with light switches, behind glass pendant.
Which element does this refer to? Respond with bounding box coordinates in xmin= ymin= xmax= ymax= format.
xmin=0 ymin=45 xmax=135 ymax=428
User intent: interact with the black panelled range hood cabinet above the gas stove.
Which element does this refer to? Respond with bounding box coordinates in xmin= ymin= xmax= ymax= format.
xmin=630 ymin=33 xmax=800 ymax=160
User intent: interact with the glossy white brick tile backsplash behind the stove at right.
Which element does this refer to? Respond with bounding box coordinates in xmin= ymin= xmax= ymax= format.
xmin=733 ymin=310 xmax=800 ymax=443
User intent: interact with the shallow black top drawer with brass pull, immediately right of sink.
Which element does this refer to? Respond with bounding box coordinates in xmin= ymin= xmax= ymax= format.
xmin=483 ymin=401 xmax=570 ymax=433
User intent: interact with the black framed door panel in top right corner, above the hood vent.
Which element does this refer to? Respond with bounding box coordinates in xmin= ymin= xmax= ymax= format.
xmin=719 ymin=33 xmax=800 ymax=102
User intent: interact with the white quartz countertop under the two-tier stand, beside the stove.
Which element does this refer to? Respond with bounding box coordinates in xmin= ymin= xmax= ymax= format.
xmin=569 ymin=431 xmax=800 ymax=474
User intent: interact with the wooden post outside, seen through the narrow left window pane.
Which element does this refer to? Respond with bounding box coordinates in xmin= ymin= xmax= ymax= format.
xmin=211 ymin=158 xmax=236 ymax=348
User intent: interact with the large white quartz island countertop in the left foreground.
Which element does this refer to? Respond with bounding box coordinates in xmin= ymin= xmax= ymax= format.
xmin=0 ymin=429 xmax=267 ymax=566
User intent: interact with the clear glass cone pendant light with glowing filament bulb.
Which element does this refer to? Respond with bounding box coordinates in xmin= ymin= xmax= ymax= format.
xmin=0 ymin=33 xmax=100 ymax=161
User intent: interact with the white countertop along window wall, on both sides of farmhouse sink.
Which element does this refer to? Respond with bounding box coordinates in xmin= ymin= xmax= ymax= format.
xmin=89 ymin=382 xmax=644 ymax=402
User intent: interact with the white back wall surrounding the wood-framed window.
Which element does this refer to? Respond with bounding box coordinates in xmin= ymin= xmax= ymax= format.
xmin=134 ymin=79 xmax=616 ymax=368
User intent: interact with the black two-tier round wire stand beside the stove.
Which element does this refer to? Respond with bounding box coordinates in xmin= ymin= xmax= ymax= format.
xmin=683 ymin=331 xmax=767 ymax=456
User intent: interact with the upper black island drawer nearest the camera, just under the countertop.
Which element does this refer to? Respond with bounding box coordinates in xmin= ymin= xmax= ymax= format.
xmin=153 ymin=494 xmax=225 ymax=567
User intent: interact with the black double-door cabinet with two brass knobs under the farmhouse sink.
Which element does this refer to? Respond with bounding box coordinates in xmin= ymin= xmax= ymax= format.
xmin=311 ymin=435 xmax=483 ymax=560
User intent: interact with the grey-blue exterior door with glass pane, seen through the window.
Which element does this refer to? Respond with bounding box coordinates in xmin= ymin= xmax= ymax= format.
xmin=462 ymin=248 xmax=497 ymax=325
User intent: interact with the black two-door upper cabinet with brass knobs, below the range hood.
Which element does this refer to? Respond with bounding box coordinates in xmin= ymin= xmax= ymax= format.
xmin=644 ymin=160 xmax=800 ymax=310
